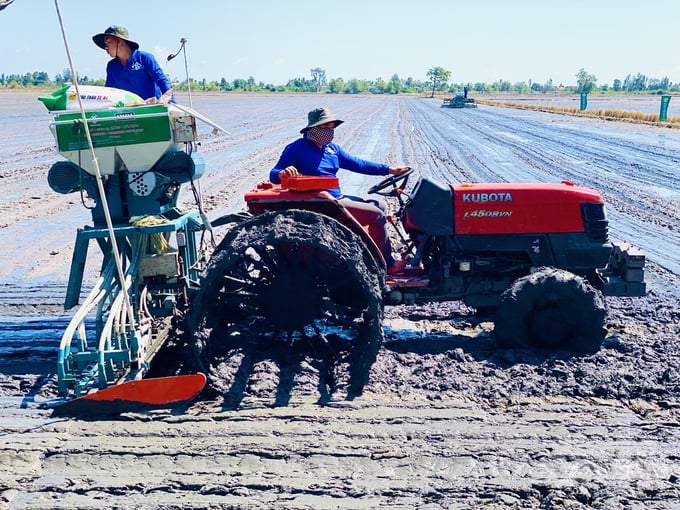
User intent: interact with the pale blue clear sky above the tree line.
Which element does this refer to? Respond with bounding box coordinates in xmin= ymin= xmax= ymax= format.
xmin=0 ymin=0 xmax=680 ymax=85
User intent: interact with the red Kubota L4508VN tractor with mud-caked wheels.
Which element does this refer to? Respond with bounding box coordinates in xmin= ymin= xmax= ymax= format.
xmin=189 ymin=170 xmax=645 ymax=394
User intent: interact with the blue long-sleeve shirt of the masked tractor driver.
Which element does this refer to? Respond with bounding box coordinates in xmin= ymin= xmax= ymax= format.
xmin=269 ymin=137 xmax=390 ymax=198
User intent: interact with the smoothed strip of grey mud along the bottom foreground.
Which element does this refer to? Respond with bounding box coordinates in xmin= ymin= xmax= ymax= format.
xmin=3 ymin=395 xmax=678 ymax=509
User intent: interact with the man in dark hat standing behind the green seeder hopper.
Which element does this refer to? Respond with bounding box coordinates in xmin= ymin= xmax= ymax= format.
xmin=92 ymin=25 xmax=175 ymax=104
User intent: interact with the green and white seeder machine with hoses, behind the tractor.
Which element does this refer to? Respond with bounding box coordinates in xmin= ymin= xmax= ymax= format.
xmin=48 ymin=95 xmax=205 ymax=399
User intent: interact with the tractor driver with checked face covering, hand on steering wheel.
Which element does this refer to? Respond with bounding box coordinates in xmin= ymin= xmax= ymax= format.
xmin=269 ymin=108 xmax=411 ymax=273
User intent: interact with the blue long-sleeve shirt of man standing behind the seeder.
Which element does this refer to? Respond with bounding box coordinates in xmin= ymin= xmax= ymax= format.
xmin=106 ymin=50 xmax=172 ymax=99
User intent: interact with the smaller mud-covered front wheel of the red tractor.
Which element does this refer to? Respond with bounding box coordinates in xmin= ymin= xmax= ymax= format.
xmin=494 ymin=267 xmax=607 ymax=353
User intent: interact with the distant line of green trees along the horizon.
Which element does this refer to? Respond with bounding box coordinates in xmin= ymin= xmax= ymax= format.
xmin=0 ymin=67 xmax=680 ymax=96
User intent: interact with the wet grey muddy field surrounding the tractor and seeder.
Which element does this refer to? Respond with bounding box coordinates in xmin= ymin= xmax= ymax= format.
xmin=0 ymin=93 xmax=680 ymax=509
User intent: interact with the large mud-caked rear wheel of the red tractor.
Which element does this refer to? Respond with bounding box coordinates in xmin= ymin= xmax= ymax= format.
xmin=188 ymin=210 xmax=384 ymax=393
